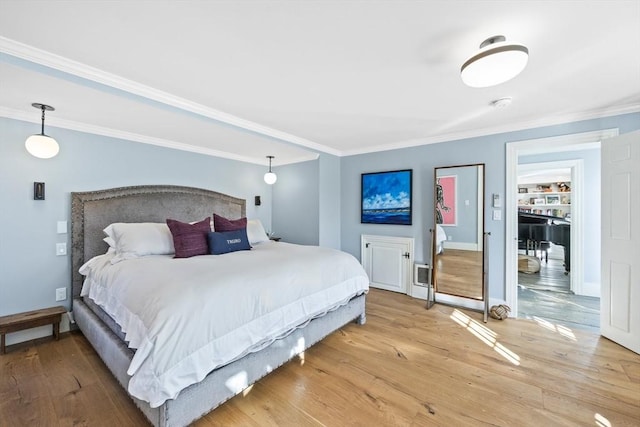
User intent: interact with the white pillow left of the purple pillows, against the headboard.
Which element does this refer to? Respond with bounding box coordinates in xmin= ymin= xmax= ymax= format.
xmin=103 ymin=222 xmax=175 ymax=264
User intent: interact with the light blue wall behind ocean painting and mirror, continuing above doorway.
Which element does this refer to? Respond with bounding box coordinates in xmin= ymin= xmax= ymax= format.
xmin=341 ymin=113 xmax=640 ymax=299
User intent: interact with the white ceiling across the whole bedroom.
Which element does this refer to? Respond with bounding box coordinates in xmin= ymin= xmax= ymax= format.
xmin=0 ymin=0 xmax=640 ymax=165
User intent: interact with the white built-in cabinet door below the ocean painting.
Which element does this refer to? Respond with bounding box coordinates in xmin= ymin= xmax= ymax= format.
xmin=361 ymin=234 xmax=414 ymax=294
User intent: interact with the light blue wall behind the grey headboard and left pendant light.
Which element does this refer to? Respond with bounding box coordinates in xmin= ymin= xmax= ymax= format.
xmin=0 ymin=118 xmax=272 ymax=343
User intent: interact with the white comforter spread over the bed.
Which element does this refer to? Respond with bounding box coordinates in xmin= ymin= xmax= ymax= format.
xmin=80 ymin=242 xmax=369 ymax=407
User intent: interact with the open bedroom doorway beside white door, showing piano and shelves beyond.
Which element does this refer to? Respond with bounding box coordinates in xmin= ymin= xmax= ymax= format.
xmin=517 ymin=162 xmax=600 ymax=329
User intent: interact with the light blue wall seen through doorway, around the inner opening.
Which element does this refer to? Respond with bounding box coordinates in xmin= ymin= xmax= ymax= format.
xmin=518 ymin=149 xmax=602 ymax=284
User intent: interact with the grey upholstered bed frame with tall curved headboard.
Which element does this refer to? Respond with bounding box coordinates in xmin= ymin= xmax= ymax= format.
xmin=71 ymin=185 xmax=366 ymax=427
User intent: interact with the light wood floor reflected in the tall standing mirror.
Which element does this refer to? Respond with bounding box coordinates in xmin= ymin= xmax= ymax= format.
xmin=436 ymin=249 xmax=482 ymax=299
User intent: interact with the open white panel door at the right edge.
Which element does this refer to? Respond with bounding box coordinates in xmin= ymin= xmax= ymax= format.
xmin=600 ymin=131 xmax=640 ymax=353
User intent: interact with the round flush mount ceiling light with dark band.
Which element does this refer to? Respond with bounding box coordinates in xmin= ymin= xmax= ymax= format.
xmin=460 ymin=36 xmax=529 ymax=87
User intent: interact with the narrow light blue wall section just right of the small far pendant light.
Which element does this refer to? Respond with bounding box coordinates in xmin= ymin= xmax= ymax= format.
xmin=272 ymin=160 xmax=320 ymax=245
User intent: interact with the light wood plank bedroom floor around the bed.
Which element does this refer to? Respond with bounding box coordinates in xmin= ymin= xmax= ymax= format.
xmin=0 ymin=289 xmax=640 ymax=427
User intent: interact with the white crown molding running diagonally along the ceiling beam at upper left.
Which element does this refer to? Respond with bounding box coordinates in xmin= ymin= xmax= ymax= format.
xmin=0 ymin=36 xmax=340 ymax=156
